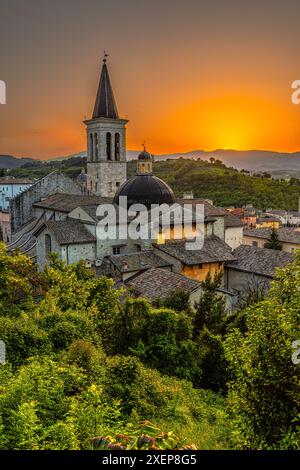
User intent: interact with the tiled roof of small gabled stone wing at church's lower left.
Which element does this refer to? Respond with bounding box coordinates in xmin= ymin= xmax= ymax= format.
xmin=34 ymin=219 xmax=96 ymax=245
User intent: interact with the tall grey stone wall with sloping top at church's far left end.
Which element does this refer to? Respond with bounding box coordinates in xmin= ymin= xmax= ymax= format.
xmin=10 ymin=172 xmax=83 ymax=232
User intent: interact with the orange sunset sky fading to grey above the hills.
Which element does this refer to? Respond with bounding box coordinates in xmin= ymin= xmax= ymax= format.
xmin=0 ymin=0 xmax=300 ymax=159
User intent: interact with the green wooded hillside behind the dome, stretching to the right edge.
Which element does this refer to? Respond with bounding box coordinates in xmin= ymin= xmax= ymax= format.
xmin=129 ymin=159 xmax=300 ymax=210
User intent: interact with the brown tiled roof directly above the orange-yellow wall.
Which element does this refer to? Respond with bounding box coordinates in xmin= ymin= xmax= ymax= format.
xmin=154 ymin=235 xmax=235 ymax=265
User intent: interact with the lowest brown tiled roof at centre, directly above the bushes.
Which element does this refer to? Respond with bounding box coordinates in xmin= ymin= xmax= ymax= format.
xmin=126 ymin=268 xmax=201 ymax=300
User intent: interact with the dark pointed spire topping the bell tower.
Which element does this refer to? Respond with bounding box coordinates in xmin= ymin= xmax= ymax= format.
xmin=93 ymin=59 xmax=119 ymax=119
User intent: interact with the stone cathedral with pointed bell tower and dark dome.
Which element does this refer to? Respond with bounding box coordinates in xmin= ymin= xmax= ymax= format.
xmin=11 ymin=56 xmax=239 ymax=302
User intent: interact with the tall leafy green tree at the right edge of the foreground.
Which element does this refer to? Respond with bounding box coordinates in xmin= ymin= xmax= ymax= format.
xmin=225 ymin=252 xmax=300 ymax=449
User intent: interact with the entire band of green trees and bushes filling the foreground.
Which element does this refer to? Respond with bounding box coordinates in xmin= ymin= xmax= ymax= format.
xmin=0 ymin=244 xmax=300 ymax=449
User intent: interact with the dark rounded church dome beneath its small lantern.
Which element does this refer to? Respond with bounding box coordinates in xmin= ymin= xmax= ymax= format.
xmin=114 ymin=174 xmax=175 ymax=209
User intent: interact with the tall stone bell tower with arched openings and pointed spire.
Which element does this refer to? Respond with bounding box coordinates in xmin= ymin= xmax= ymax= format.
xmin=84 ymin=54 xmax=128 ymax=197
